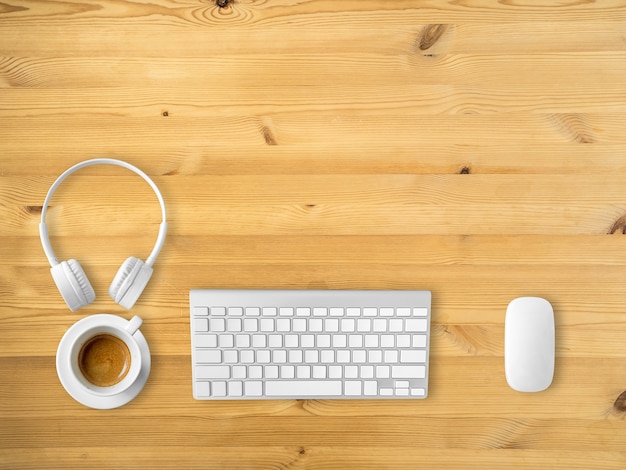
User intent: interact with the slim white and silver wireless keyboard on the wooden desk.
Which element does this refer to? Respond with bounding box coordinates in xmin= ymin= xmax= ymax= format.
xmin=189 ymin=289 xmax=431 ymax=400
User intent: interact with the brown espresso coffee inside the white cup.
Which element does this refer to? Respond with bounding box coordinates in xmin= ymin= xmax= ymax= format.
xmin=78 ymin=333 xmax=130 ymax=387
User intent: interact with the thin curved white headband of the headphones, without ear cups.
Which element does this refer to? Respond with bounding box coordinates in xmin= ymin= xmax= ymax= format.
xmin=39 ymin=158 xmax=167 ymax=267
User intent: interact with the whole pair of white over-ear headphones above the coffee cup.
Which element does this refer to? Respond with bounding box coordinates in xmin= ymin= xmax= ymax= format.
xmin=39 ymin=158 xmax=167 ymax=312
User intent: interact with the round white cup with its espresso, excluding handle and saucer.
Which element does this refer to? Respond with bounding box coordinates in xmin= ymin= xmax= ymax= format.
xmin=70 ymin=325 xmax=141 ymax=396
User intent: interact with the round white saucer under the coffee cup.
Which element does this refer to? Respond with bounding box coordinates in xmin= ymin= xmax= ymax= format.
xmin=56 ymin=314 xmax=151 ymax=410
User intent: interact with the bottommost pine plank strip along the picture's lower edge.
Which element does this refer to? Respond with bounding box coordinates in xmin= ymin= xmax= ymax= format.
xmin=0 ymin=444 xmax=624 ymax=470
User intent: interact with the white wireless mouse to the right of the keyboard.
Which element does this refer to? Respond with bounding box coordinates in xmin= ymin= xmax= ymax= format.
xmin=504 ymin=297 xmax=554 ymax=392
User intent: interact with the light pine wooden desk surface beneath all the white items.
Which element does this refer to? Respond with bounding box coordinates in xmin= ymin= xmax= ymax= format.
xmin=0 ymin=0 xmax=626 ymax=470
